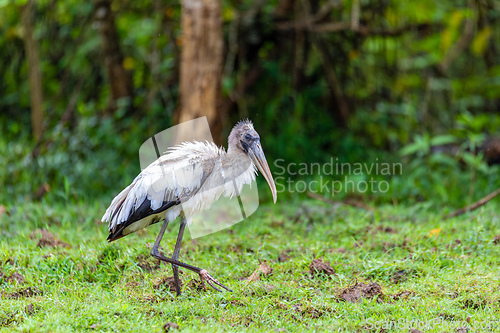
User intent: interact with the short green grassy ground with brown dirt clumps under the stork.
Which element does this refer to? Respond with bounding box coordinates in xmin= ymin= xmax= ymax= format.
xmin=0 ymin=201 xmax=500 ymax=332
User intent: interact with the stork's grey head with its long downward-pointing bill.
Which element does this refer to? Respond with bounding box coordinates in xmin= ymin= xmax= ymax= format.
xmin=228 ymin=120 xmax=277 ymax=203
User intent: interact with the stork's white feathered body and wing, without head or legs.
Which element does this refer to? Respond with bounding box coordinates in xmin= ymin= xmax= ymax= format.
xmin=102 ymin=139 xmax=256 ymax=235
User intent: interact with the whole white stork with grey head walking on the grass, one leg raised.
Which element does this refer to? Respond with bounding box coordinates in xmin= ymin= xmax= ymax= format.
xmin=102 ymin=120 xmax=277 ymax=295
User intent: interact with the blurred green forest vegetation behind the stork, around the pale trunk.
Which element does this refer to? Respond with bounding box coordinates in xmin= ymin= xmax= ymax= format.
xmin=0 ymin=0 xmax=500 ymax=206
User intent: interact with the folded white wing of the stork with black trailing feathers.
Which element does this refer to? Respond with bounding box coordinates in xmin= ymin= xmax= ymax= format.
xmin=102 ymin=143 xmax=217 ymax=241
